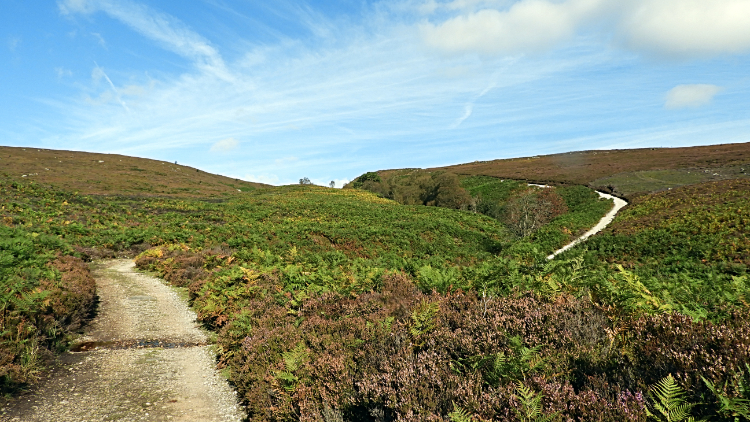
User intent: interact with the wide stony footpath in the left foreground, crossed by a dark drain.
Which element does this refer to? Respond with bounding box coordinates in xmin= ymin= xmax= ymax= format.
xmin=0 ymin=260 xmax=244 ymax=422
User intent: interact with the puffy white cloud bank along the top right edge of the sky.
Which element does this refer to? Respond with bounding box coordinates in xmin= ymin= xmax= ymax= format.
xmin=420 ymin=0 xmax=750 ymax=58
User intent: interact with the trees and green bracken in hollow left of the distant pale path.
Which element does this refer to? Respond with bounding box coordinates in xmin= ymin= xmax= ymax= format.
xmin=347 ymin=169 xmax=612 ymax=255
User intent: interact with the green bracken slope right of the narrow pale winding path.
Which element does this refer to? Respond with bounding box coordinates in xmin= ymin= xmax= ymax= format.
xmin=586 ymin=180 xmax=750 ymax=318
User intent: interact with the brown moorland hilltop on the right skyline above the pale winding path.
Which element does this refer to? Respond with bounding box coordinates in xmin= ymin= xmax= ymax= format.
xmin=428 ymin=143 xmax=750 ymax=198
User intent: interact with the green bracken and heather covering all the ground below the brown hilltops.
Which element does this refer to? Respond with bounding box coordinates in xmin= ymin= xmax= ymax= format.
xmin=0 ymin=146 xmax=750 ymax=422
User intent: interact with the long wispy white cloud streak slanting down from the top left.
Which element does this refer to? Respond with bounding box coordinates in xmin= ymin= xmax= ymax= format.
xmin=58 ymin=0 xmax=229 ymax=79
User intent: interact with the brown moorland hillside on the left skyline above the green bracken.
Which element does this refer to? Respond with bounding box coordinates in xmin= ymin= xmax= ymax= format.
xmin=0 ymin=146 xmax=266 ymax=198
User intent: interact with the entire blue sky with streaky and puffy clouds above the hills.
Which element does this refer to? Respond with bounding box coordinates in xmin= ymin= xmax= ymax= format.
xmin=0 ymin=0 xmax=750 ymax=186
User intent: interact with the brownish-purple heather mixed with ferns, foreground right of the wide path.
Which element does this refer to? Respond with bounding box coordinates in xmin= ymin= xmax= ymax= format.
xmin=137 ymin=247 xmax=750 ymax=421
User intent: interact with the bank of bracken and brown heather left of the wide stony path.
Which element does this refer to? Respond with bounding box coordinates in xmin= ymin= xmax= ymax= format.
xmin=0 ymin=226 xmax=94 ymax=393
